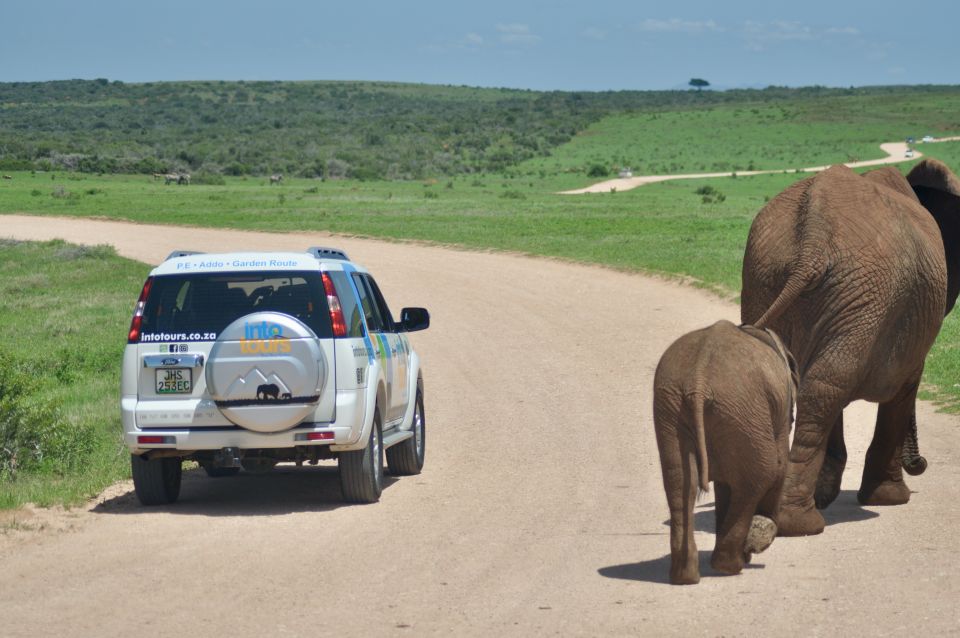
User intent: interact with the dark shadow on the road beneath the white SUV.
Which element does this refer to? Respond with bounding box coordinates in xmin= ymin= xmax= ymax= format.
xmin=90 ymin=465 xmax=397 ymax=516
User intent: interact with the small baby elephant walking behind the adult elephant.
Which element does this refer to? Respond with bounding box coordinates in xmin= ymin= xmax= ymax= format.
xmin=653 ymin=321 xmax=797 ymax=585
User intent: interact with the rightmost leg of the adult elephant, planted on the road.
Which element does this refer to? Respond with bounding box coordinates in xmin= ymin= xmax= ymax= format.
xmin=857 ymin=382 xmax=919 ymax=505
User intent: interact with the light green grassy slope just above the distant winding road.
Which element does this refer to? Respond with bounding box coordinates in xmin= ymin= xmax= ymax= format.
xmin=517 ymin=94 xmax=960 ymax=186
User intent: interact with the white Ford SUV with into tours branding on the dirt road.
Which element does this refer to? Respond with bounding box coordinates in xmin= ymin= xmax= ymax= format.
xmin=120 ymin=248 xmax=430 ymax=505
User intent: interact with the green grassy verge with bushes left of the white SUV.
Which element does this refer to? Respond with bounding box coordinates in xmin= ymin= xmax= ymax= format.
xmin=0 ymin=240 xmax=147 ymax=508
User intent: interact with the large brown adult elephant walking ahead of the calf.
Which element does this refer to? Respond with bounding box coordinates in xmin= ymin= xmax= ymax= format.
xmin=741 ymin=161 xmax=960 ymax=535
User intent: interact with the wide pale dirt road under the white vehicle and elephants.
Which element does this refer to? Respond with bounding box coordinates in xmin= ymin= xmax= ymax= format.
xmin=0 ymin=216 xmax=960 ymax=637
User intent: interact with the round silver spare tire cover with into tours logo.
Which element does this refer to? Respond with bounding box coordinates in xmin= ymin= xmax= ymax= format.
xmin=205 ymin=312 xmax=327 ymax=432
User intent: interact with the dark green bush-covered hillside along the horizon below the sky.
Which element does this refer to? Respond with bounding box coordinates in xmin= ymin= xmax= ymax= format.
xmin=0 ymin=79 xmax=960 ymax=179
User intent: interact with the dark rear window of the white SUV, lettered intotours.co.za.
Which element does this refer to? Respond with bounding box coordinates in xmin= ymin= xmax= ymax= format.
xmin=140 ymin=271 xmax=333 ymax=342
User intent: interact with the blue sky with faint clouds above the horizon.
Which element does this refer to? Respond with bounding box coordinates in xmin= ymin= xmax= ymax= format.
xmin=0 ymin=0 xmax=960 ymax=90
